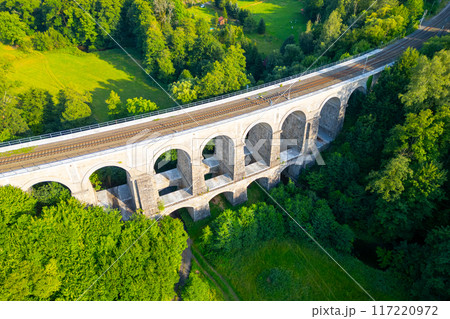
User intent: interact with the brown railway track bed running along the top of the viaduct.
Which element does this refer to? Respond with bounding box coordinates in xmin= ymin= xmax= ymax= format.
xmin=0 ymin=8 xmax=449 ymax=172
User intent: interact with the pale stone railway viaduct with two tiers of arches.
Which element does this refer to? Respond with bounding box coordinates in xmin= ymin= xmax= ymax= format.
xmin=0 ymin=7 xmax=448 ymax=220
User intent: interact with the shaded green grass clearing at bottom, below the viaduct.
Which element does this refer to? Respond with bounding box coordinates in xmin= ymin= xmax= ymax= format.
xmin=212 ymin=239 xmax=407 ymax=301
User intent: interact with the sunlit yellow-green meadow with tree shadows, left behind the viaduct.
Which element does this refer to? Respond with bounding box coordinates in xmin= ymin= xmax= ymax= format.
xmin=0 ymin=45 xmax=174 ymax=122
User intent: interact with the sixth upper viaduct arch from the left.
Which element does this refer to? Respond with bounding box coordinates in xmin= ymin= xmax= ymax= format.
xmin=280 ymin=109 xmax=306 ymax=160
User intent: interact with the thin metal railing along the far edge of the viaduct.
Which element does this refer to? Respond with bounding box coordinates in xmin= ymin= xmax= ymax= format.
xmin=0 ymin=38 xmax=398 ymax=148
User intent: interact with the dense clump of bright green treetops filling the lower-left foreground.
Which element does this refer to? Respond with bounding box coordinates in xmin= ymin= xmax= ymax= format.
xmin=0 ymin=186 xmax=187 ymax=300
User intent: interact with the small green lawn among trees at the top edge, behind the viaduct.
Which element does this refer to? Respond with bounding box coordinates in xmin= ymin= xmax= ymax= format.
xmin=238 ymin=0 xmax=308 ymax=53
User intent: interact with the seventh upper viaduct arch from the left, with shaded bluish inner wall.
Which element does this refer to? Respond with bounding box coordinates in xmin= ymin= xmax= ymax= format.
xmin=318 ymin=97 xmax=343 ymax=143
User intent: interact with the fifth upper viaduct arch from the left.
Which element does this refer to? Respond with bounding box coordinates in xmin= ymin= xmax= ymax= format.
xmin=242 ymin=122 xmax=273 ymax=169
